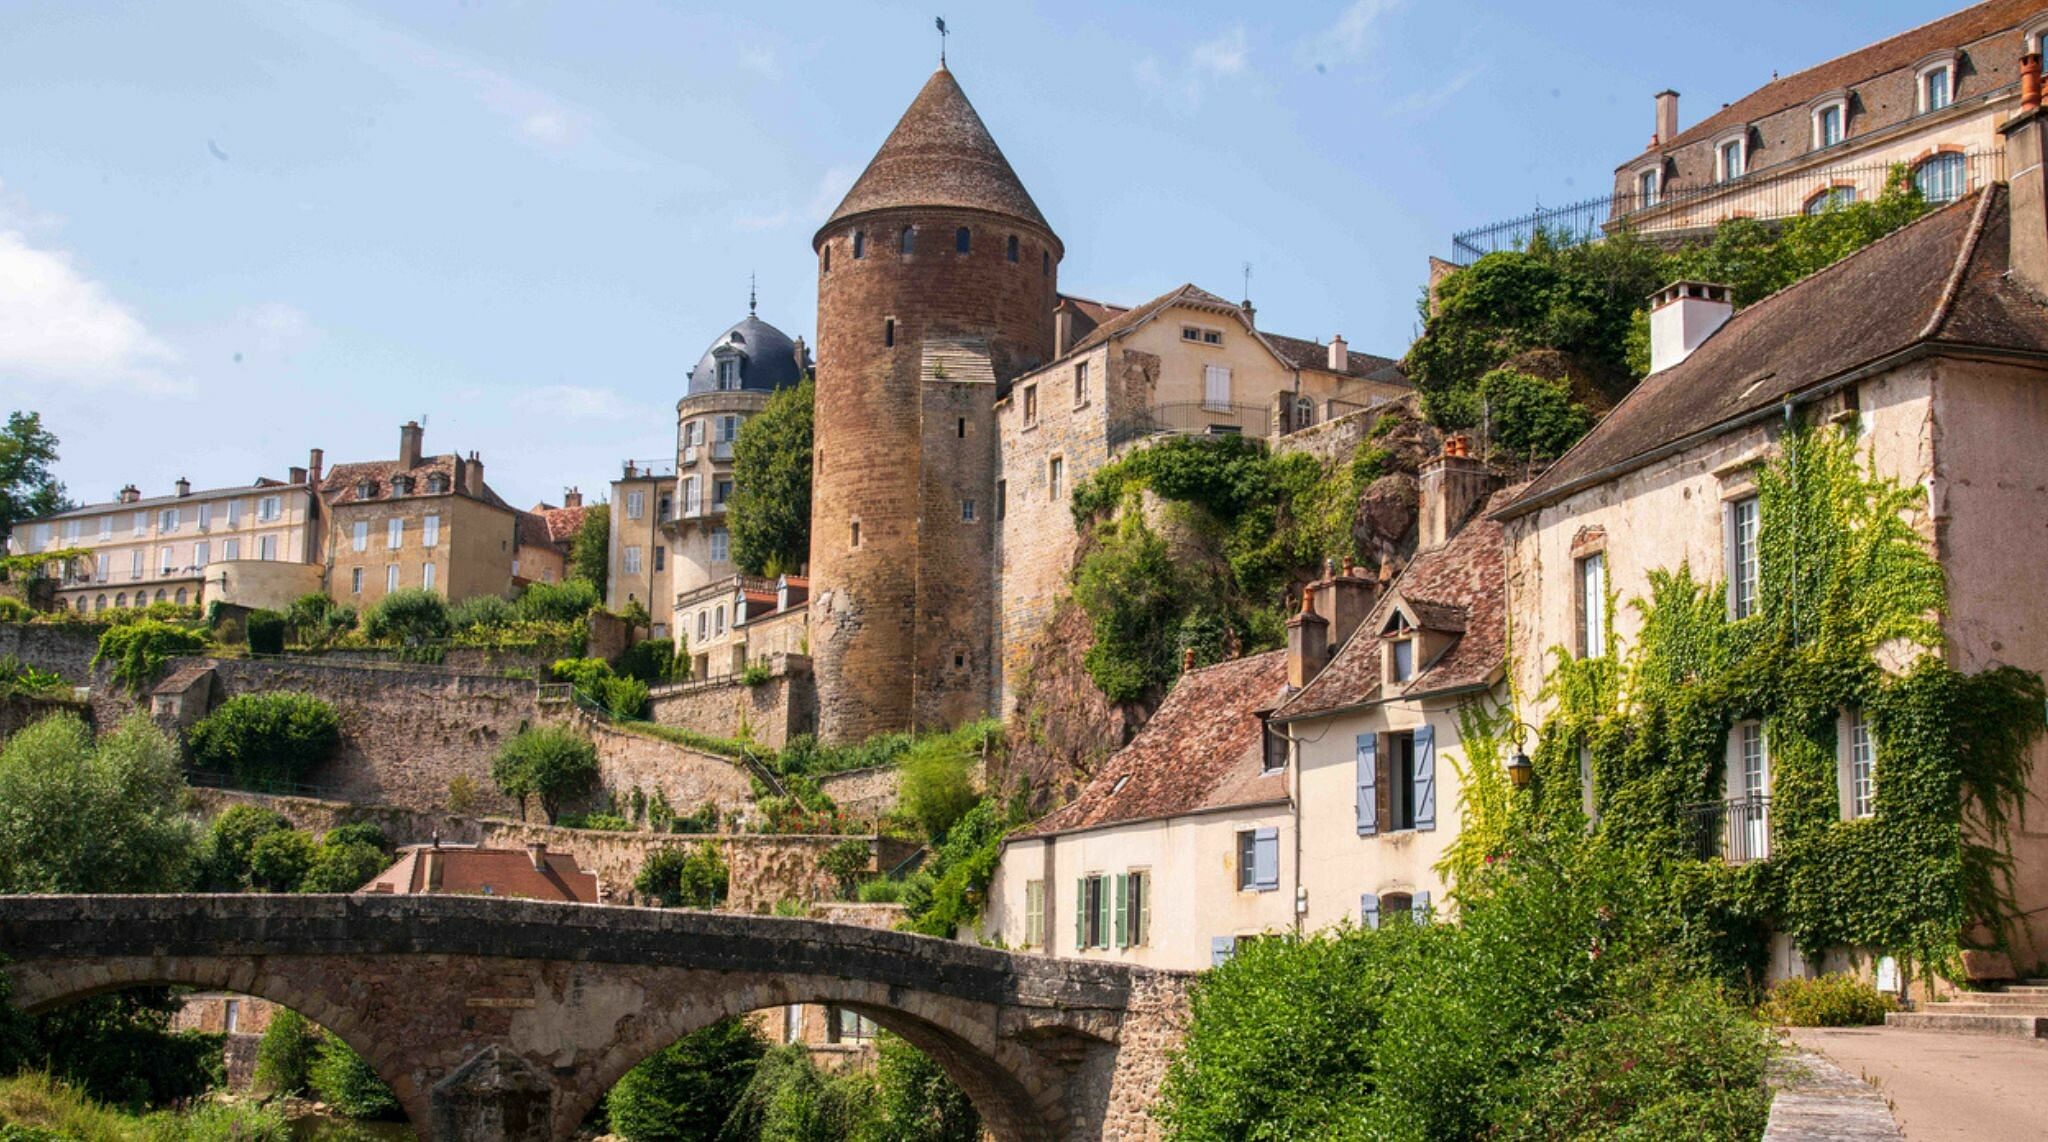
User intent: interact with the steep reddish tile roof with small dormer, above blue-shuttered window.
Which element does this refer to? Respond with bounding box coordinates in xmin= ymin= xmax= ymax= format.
xmin=1274 ymin=501 xmax=1511 ymax=720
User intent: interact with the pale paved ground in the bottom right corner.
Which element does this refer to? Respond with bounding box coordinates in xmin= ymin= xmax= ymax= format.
xmin=1792 ymin=1027 xmax=2048 ymax=1142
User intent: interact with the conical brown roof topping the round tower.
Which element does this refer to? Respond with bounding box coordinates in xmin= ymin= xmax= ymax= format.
xmin=813 ymin=68 xmax=1053 ymax=246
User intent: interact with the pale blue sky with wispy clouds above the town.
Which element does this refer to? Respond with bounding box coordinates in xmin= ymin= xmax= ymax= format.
xmin=0 ymin=0 xmax=1952 ymax=506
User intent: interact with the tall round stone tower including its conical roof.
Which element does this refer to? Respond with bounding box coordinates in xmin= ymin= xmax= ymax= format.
xmin=811 ymin=68 xmax=1063 ymax=743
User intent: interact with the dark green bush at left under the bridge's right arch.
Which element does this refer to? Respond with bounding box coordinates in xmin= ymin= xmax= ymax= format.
xmin=604 ymin=1019 xmax=768 ymax=1142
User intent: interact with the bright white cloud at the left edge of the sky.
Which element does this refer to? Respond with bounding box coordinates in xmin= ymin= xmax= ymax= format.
xmin=0 ymin=217 xmax=190 ymax=395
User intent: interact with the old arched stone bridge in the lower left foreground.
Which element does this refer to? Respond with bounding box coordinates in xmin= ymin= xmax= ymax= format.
xmin=0 ymin=894 xmax=1188 ymax=1142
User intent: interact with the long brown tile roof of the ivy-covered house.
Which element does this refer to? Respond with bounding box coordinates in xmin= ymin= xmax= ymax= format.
xmin=1499 ymin=184 xmax=2048 ymax=518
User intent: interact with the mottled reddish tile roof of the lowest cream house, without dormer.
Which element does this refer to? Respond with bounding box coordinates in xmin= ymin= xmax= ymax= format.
xmin=1020 ymin=651 xmax=1286 ymax=837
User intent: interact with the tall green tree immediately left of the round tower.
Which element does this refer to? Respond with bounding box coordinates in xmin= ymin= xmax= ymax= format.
xmin=725 ymin=377 xmax=815 ymax=575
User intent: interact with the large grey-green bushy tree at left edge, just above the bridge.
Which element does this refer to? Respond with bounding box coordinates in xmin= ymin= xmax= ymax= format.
xmin=0 ymin=714 xmax=197 ymax=892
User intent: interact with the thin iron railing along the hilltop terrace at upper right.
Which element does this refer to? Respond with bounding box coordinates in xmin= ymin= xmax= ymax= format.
xmin=1450 ymin=151 xmax=2005 ymax=266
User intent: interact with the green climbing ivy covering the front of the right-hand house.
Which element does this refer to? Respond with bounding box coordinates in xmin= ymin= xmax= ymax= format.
xmin=1523 ymin=428 xmax=2044 ymax=980
